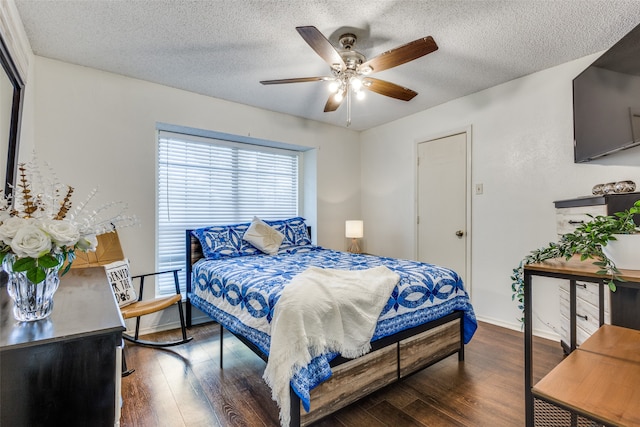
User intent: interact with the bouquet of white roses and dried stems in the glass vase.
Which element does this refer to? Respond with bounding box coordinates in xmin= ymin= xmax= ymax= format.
xmin=0 ymin=158 xmax=137 ymax=284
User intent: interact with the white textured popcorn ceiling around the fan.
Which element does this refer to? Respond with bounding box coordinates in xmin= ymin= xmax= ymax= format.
xmin=15 ymin=0 xmax=640 ymax=130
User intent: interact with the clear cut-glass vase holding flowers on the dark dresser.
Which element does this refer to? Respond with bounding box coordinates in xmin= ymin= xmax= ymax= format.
xmin=2 ymin=254 xmax=61 ymax=322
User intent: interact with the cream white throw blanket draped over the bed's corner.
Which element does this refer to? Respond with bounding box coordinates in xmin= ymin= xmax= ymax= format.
xmin=263 ymin=266 xmax=400 ymax=426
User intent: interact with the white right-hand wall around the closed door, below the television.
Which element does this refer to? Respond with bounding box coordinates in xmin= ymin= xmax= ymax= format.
xmin=361 ymin=55 xmax=640 ymax=334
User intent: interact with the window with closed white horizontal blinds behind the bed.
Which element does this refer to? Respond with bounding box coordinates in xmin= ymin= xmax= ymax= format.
xmin=156 ymin=130 xmax=301 ymax=295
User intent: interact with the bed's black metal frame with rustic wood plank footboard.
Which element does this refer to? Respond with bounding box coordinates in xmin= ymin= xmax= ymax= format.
xmin=186 ymin=230 xmax=464 ymax=427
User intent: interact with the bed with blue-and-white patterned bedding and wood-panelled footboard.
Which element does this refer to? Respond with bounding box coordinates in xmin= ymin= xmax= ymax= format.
xmin=186 ymin=218 xmax=477 ymax=426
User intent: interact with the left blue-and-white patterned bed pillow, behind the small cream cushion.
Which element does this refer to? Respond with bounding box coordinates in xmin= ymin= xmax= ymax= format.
xmin=192 ymin=222 xmax=260 ymax=259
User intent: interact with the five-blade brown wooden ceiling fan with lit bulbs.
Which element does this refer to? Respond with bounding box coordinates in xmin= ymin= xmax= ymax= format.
xmin=260 ymin=26 xmax=438 ymax=126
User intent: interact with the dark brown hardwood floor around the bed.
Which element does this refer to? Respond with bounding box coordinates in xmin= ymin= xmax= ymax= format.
xmin=121 ymin=323 xmax=562 ymax=427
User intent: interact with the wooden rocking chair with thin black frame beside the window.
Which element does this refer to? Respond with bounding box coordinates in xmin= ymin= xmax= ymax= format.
xmin=71 ymin=231 xmax=193 ymax=376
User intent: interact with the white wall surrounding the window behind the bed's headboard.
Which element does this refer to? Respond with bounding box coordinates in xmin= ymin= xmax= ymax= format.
xmin=26 ymin=56 xmax=360 ymax=332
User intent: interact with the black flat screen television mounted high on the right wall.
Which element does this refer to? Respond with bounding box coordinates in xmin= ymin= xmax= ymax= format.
xmin=573 ymin=25 xmax=640 ymax=163
